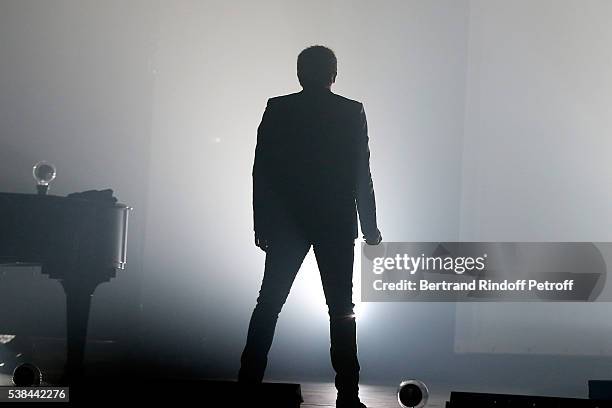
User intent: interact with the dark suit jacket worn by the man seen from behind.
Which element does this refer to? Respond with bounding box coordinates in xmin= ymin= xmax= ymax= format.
xmin=253 ymin=89 xmax=378 ymax=242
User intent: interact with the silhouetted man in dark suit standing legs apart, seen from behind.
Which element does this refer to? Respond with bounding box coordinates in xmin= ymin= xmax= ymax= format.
xmin=238 ymin=46 xmax=382 ymax=408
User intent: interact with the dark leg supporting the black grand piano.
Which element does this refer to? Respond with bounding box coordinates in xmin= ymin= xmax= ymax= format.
xmin=62 ymin=281 xmax=95 ymax=382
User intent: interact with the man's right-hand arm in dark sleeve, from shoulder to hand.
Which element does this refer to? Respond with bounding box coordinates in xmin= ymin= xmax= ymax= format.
xmin=357 ymin=105 xmax=382 ymax=245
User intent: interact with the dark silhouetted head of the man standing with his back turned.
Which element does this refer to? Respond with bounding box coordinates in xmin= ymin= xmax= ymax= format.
xmin=297 ymin=45 xmax=338 ymax=88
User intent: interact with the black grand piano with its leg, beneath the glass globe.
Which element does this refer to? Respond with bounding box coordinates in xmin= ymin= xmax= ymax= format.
xmin=0 ymin=193 xmax=131 ymax=381
